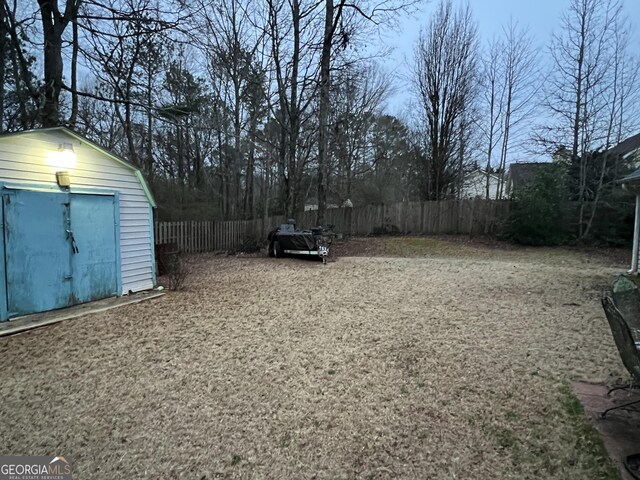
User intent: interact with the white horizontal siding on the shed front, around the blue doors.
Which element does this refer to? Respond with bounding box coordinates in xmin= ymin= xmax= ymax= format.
xmin=0 ymin=131 xmax=153 ymax=294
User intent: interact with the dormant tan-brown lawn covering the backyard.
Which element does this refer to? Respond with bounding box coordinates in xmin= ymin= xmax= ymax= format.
xmin=0 ymin=238 xmax=626 ymax=479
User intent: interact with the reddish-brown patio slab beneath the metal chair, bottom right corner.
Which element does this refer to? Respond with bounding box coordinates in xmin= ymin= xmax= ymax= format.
xmin=573 ymin=382 xmax=640 ymax=480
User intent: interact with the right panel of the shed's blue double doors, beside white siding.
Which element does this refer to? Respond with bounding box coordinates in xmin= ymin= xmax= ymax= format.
xmin=71 ymin=193 xmax=118 ymax=303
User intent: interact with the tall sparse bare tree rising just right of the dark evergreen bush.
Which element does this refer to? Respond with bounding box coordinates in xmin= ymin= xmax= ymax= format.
xmin=542 ymin=0 xmax=621 ymax=238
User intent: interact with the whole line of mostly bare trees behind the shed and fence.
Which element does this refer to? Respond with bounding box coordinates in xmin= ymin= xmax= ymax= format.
xmin=0 ymin=0 xmax=639 ymax=240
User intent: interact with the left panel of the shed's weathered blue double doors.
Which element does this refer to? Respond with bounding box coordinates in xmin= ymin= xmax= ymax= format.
xmin=2 ymin=190 xmax=73 ymax=317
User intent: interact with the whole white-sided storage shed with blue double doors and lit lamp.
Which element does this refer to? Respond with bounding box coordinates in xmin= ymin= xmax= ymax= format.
xmin=0 ymin=127 xmax=155 ymax=321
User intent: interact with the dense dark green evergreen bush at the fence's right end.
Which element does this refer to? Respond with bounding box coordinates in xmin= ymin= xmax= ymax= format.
xmin=503 ymin=163 xmax=570 ymax=245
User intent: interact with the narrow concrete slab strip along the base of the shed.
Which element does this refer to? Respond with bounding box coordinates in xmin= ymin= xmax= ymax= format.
xmin=0 ymin=290 xmax=165 ymax=337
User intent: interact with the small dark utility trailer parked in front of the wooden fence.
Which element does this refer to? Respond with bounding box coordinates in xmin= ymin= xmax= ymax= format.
xmin=267 ymin=219 xmax=335 ymax=263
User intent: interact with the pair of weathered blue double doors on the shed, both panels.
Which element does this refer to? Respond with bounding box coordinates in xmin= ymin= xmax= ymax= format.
xmin=2 ymin=189 xmax=118 ymax=318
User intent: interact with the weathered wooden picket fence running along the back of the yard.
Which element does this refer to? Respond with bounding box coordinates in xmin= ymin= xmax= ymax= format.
xmin=154 ymin=199 xmax=510 ymax=253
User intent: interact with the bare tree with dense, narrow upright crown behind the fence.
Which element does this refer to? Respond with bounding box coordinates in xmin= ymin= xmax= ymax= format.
xmin=414 ymin=0 xmax=477 ymax=200
